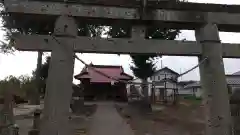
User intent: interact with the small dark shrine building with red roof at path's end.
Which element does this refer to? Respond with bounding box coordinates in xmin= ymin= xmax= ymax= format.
xmin=74 ymin=64 xmax=133 ymax=101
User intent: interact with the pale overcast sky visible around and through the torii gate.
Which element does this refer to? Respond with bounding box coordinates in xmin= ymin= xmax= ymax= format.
xmin=0 ymin=0 xmax=240 ymax=82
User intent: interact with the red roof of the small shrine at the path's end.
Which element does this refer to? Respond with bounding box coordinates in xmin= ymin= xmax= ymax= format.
xmin=75 ymin=65 xmax=133 ymax=83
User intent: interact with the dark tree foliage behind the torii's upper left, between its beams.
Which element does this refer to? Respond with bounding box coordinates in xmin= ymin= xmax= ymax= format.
xmin=0 ymin=7 xmax=104 ymax=53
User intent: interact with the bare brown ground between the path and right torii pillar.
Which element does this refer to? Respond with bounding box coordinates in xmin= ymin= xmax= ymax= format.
xmin=116 ymin=100 xmax=204 ymax=135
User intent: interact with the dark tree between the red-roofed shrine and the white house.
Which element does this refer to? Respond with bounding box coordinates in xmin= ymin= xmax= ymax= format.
xmin=107 ymin=24 xmax=180 ymax=110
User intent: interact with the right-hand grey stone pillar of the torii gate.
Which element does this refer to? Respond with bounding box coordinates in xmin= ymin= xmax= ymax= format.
xmin=195 ymin=23 xmax=232 ymax=135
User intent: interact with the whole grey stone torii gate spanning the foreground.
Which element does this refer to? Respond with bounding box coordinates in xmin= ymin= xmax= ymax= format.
xmin=4 ymin=0 xmax=240 ymax=135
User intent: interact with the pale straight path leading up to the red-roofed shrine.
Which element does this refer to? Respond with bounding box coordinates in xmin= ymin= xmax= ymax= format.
xmin=89 ymin=102 xmax=134 ymax=135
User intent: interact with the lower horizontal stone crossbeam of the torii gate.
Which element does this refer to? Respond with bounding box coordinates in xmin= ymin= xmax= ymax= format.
xmin=15 ymin=35 xmax=240 ymax=58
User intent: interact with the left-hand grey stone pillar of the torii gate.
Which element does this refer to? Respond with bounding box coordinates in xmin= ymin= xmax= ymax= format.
xmin=40 ymin=16 xmax=77 ymax=135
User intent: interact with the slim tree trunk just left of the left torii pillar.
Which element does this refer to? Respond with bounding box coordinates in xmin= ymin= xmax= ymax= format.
xmin=30 ymin=51 xmax=43 ymax=105
